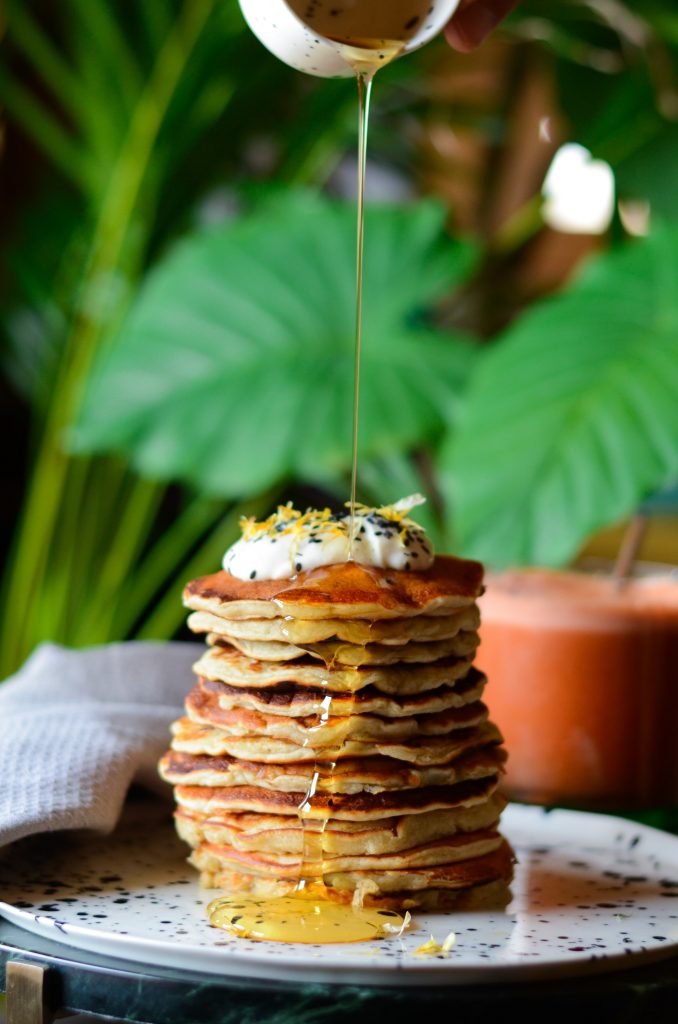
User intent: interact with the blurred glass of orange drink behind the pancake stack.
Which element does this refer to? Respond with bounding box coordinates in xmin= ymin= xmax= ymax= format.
xmin=477 ymin=569 xmax=678 ymax=809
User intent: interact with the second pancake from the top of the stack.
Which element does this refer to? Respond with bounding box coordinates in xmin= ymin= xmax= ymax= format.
xmin=186 ymin=605 xmax=480 ymax=644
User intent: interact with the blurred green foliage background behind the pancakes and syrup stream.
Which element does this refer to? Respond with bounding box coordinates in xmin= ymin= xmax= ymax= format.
xmin=0 ymin=0 xmax=678 ymax=675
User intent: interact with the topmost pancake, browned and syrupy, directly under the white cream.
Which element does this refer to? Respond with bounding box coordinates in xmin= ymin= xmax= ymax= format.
xmin=183 ymin=555 xmax=482 ymax=622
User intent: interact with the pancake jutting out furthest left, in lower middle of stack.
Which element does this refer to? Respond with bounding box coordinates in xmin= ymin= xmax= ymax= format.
xmin=159 ymin=746 xmax=504 ymax=794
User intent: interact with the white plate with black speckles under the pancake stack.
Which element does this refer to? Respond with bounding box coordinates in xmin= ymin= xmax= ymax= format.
xmin=0 ymin=803 xmax=678 ymax=985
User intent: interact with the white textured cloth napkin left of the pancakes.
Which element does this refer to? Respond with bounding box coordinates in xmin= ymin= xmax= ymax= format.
xmin=0 ymin=641 xmax=197 ymax=847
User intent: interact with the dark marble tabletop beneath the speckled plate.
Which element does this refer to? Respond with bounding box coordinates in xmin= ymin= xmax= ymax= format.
xmin=0 ymin=920 xmax=678 ymax=1024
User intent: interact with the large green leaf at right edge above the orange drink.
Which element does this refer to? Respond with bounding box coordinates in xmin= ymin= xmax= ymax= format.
xmin=441 ymin=228 xmax=678 ymax=566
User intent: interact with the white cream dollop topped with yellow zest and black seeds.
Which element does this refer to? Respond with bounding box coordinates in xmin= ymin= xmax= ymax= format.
xmin=222 ymin=495 xmax=434 ymax=580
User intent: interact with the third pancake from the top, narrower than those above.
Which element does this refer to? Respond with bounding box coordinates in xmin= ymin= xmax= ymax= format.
xmin=222 ymin=630 xmax=479 ymax=668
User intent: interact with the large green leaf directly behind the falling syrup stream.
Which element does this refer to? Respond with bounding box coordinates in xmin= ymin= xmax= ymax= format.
xmin=74 ymin=193 xmax=474 ymax=498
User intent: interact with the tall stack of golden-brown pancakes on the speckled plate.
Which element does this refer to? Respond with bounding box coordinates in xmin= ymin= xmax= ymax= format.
xmin=160 ymin=556 xmax=512 ymax=909
